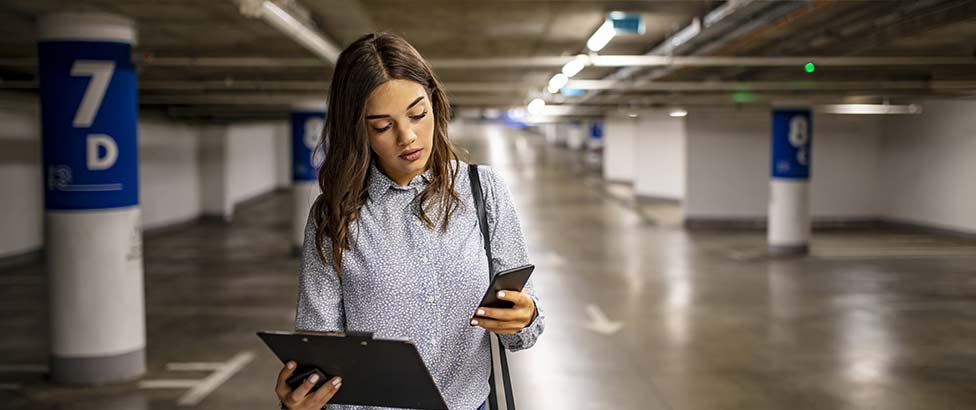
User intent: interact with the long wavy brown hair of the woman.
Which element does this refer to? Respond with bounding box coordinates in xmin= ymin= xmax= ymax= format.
xmin=312 ymin=33 xmax=460 ymax=277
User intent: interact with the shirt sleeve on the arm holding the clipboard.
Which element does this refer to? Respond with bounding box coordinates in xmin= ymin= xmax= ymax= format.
xmin=295 ymin=216 xmax=346 ymax=332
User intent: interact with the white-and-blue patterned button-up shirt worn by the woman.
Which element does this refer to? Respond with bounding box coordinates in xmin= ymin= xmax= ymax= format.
xmin=295 ymin=162 xmax=544 ymax=410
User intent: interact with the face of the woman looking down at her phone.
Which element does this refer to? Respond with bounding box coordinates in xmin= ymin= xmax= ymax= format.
xmin=366 ymin=80 xmax=434 ymax=185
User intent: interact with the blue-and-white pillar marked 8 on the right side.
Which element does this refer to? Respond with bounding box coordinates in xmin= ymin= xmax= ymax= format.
xmin=767 ymin=108 xmax=813 ymax=255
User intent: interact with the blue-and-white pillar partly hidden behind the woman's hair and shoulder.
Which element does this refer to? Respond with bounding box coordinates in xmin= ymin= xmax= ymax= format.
xmin=291 ymin=101 xmax=325 ymax=249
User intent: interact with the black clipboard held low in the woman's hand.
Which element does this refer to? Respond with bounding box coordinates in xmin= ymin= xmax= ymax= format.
xmin=258 ymin=331 xmax=447 ymax=410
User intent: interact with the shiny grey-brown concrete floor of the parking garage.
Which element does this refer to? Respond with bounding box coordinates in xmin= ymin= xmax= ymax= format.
xmin=0 ymin=123 xmax=976 ymax=410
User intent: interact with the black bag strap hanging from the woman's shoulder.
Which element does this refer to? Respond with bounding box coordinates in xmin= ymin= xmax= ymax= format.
xmin=468 ymin=164 xmax=515 ymax=410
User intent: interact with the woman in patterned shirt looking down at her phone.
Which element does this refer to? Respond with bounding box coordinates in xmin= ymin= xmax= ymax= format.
xmin=275 ymin=33 xmax=544 ymax=410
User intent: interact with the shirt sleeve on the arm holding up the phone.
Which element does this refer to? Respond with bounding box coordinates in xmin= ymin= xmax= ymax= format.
xmin=481 ymin=167 xmax=545 ymax=352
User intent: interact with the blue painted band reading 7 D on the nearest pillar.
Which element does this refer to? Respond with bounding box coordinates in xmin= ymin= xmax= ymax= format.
xmin=38 ymin=40 xmax=139 ymax=210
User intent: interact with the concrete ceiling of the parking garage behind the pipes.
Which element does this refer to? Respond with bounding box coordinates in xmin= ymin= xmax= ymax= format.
xmin=0 ymin=0 xmax=976 ymax=118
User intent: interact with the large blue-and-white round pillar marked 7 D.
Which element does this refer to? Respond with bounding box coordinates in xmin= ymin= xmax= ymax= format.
xmin=38 ymin=13 xmax=146 ymax=385
